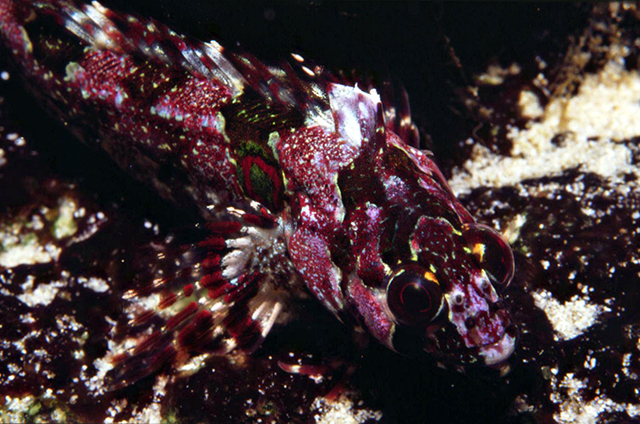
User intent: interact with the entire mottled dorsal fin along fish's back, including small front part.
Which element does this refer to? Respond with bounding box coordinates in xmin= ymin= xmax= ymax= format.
xmin=35 ymin=0 xmax=419 ymax=146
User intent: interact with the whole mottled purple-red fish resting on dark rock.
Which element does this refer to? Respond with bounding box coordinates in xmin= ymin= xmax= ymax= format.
xmin=0 ymin=0 xmax=516 ymax=388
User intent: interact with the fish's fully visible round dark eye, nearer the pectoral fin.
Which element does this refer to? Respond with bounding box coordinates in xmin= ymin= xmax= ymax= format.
xmin=387 ymin=265 xmax=443 ymax=325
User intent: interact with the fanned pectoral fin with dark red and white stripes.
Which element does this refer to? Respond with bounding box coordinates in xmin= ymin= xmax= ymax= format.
xmin=107 ymin=208 xmax=302 ymax=390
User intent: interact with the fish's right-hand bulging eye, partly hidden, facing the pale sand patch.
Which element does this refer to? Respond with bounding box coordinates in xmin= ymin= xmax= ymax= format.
xmin=464 ymin=223 xmax=515 ymax=287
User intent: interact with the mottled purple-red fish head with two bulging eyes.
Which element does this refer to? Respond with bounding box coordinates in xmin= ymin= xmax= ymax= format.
xmin=341 ymin=134 xmax=516 ymax=368
